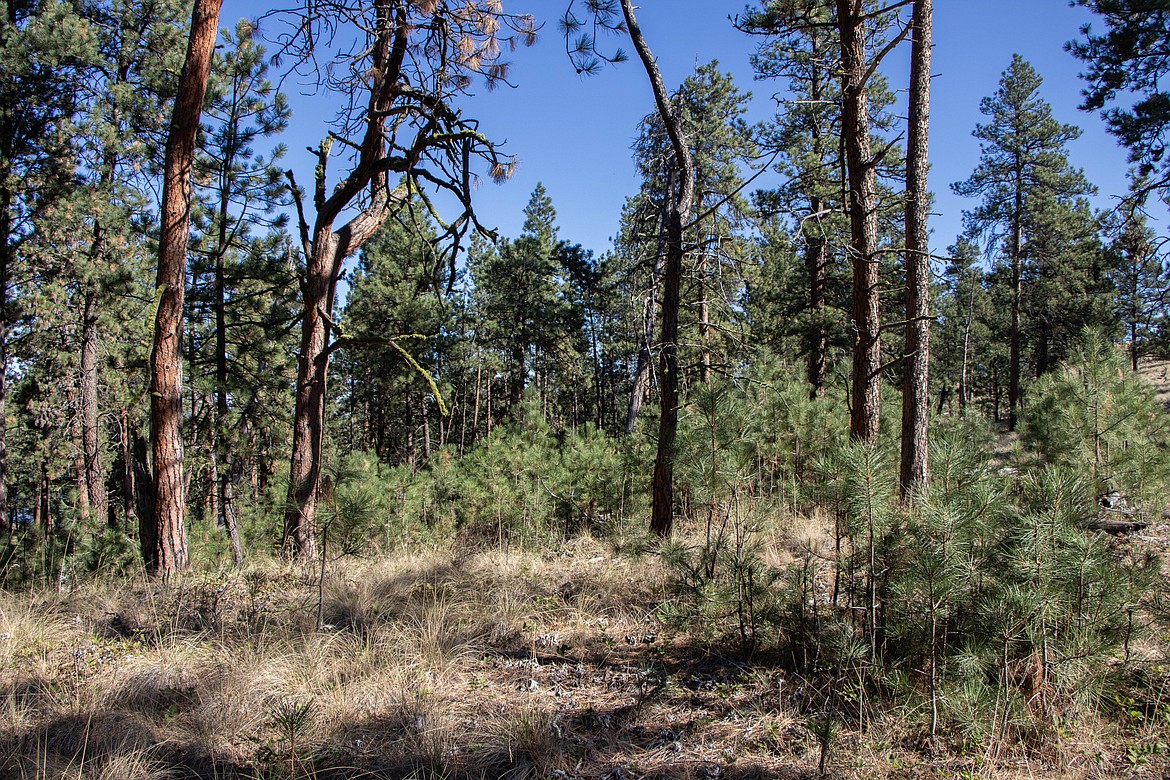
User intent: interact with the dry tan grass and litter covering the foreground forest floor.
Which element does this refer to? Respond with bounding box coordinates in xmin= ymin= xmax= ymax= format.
xmin=0 ymin=529 xmax=1170 ymax=780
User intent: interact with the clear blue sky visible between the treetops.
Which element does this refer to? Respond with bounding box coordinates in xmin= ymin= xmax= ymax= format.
xmin=222 ymin=0 xmax=1141 ymax=261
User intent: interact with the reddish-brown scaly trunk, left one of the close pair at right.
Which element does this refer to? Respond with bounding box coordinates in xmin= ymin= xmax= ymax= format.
xmin=837 ymin=0 xmax=881 ymax=442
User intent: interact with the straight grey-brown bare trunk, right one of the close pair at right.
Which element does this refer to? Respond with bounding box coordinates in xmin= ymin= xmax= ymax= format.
xmin=899 ymin=0 xmax=932 ymax=501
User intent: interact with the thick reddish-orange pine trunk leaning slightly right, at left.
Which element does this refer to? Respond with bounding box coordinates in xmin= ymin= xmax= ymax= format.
xmin=143 ymin=0 xmax=222 ymax=577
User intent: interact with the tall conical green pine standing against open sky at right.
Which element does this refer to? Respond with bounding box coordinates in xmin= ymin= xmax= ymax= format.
xmin=951 ymin=54 xmax=1090 ymax=429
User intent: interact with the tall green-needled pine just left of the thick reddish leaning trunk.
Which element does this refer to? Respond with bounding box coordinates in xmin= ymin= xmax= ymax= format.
xmin=75 ymin=0 xmax=187 ymax=533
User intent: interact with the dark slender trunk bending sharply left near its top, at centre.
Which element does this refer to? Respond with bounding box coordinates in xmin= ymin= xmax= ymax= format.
xmin=621 ymin=0 xmax=695 ymax=537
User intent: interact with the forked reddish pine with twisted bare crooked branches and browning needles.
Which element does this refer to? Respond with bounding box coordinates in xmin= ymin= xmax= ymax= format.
xmin=282 ymin=0 xmax=536 ymax=555
